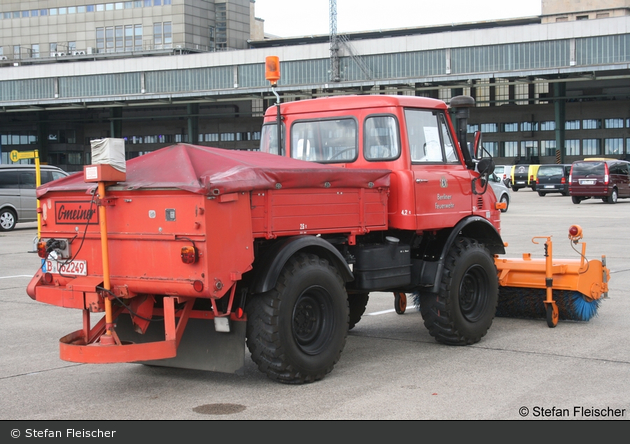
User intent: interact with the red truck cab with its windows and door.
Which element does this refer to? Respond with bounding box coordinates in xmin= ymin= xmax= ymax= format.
xmin=260 ymin=95 xmax=500 ymax=232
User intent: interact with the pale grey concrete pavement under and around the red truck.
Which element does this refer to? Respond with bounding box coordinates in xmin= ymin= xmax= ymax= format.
xmin=0 ymin=190 xmax=630 ymax=424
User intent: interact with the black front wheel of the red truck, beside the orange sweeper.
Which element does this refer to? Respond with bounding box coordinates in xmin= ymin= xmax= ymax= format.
xmin=420 ymin=237 xmax=499 ymax=345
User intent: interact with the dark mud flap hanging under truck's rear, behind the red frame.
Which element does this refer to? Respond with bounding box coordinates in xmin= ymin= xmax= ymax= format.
xmin=116 ymin=314 xmax=247 ymax=375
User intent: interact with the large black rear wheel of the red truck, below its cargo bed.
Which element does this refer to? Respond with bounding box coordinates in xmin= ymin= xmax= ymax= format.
xmin=246 ymin=253 xmax=348 ymax=384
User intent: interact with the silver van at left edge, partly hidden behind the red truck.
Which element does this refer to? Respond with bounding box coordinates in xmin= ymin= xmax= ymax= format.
xmin=0 ymin=164 xmax=68 ymax=231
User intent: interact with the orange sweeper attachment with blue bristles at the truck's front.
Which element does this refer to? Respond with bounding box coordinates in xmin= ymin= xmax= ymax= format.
xmin=495 ymin=225 xmax=610 ymax=327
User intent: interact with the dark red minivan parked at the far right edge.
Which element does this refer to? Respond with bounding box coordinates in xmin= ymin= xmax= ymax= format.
xmin=569 ymin=158 xmax=630 ymax=204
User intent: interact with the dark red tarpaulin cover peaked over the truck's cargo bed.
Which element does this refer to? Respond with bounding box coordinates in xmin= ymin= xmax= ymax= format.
xmin=37 ymin=144 xmax=390 ymax=199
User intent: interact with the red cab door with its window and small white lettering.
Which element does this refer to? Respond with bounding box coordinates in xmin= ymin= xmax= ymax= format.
xmin=405 ymin=109 xmax=472 ymax=230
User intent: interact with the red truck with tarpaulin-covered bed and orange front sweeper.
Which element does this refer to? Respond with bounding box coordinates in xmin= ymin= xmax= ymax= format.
xmin=27 ymin=57 xmax=609 ymax=383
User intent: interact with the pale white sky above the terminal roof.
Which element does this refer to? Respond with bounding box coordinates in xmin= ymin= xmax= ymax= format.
xmin=255 ymin=0 xmax=542 ymax=37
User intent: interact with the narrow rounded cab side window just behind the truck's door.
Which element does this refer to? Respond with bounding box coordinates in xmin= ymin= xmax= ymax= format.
xmin=363 ymin=116 xmax=400 ymax=160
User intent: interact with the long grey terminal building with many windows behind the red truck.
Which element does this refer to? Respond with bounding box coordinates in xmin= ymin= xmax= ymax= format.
xmin=0 ymin=0 xmax=630 ymax=171
